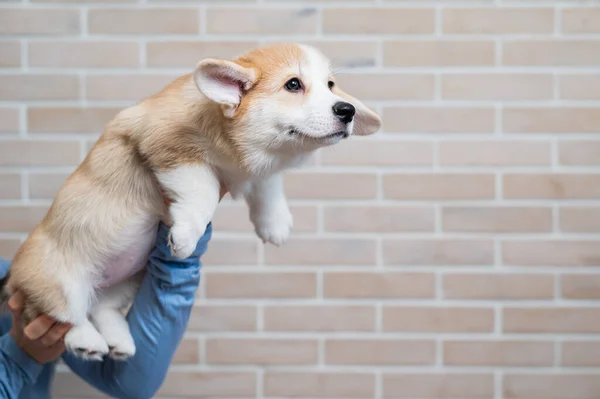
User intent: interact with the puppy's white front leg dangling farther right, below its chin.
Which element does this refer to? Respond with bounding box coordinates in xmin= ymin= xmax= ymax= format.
xmin=246 ymin=174 xmax=294 ymax=245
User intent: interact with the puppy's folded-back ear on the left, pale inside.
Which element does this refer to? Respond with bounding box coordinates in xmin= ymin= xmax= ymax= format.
xmin=194 ymin=58 xmax=258 ymax=114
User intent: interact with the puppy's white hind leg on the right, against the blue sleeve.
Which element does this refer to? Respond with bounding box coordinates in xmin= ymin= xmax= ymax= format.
xmin=91 ymin=273 xmax=143 ymax=360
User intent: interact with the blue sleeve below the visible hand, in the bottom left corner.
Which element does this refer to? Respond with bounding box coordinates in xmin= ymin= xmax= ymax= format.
xmin=0 ymin=259 xmax=44 ymax=399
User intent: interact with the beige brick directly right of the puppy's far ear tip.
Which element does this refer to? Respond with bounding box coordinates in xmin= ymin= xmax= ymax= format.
xmin=383 ymin=106 xmax=494 ymax=133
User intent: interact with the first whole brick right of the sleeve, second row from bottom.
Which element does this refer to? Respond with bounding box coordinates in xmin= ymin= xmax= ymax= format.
xmin=206 ymin=338 xmax=318 ymax=366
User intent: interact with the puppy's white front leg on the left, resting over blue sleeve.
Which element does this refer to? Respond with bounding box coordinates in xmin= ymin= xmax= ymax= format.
xmin=156 ymin=164 xmax=220 ymax=259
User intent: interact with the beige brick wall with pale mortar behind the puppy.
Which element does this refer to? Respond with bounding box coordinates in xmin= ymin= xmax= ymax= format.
xmin=0 ymin=0 xmax=600 ymax=399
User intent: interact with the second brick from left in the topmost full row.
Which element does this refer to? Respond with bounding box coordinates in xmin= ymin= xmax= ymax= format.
xmin=88 ymin=8 xmax=199 ymax=35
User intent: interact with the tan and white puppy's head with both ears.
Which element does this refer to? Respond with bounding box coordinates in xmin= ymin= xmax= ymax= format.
xmin=194 ymin=44 xmax=381 ymax=150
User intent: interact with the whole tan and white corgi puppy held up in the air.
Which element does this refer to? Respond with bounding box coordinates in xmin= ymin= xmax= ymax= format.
xmin=0 ymin=44 xmax=381 ymax=360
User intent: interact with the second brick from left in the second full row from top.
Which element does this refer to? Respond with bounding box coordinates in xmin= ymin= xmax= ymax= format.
xmin=28 ymin=40 xmax=140 ymax=68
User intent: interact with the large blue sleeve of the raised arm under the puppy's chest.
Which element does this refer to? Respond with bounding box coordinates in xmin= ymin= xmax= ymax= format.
xmin=63 ymin=223 xmax=212 ymax=399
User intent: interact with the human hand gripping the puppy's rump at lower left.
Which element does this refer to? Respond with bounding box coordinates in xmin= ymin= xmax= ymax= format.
xmin=8 ymin=292 xmax=71 ymax=364
